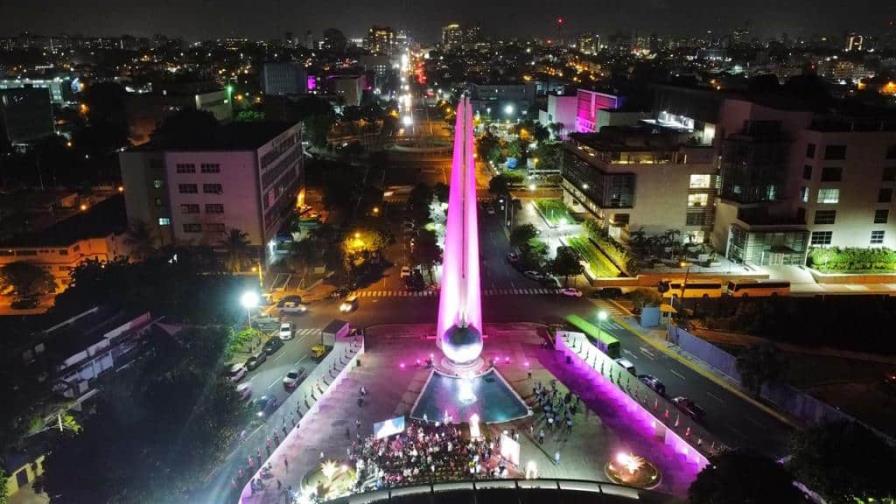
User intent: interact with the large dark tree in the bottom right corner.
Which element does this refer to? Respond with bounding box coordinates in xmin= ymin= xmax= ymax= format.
xmin=788 ymin=421 xmax=896 ymax=503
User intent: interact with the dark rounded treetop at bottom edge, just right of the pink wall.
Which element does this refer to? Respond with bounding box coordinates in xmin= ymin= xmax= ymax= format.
xmin=688 ymin=451 xmax=803 ymax=504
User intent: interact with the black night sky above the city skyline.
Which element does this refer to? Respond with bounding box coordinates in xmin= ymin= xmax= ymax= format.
xmin=0 ymin=0 xmax=896 ymax=42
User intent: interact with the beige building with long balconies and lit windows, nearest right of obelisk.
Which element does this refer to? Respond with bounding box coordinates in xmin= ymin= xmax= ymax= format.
xmin=561 ymin=126 xmax=718 ymax=243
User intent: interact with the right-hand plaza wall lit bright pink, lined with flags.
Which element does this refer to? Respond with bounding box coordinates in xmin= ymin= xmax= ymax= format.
xmin=554 ymin=333 xmax=725 ymax=470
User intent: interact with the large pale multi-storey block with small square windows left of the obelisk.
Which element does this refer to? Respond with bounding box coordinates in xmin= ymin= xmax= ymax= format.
xmin=119 ymin=122 xmax=303 ymax=253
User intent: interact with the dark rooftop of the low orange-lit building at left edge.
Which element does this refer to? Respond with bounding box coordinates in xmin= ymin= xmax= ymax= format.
xmin=0 ymin=194 xmax=127 ymax=248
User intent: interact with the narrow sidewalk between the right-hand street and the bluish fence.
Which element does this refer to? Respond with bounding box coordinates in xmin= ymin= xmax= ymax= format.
xmin=606 ymin=300 xmax=800 ymax=428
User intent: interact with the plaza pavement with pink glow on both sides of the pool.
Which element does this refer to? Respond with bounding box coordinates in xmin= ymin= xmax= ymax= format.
xmin=242 ymin=324 xmax=697 ymax=504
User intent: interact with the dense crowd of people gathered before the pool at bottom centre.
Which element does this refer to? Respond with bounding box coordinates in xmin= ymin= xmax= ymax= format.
xmin=349 ymin=420 xmax=508 ymax=492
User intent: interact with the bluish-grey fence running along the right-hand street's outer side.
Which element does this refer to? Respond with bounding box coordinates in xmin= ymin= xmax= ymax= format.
xmin=669 ymin=325 xmax=896 ymax=444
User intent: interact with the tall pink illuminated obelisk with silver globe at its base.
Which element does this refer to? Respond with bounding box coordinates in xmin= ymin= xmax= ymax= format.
xmin=436 ymin=96 xmax=482 ymax=364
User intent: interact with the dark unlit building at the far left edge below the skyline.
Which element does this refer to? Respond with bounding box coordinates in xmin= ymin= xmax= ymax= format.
xmin=0 ymin=88 xmax=55 ymax=148
